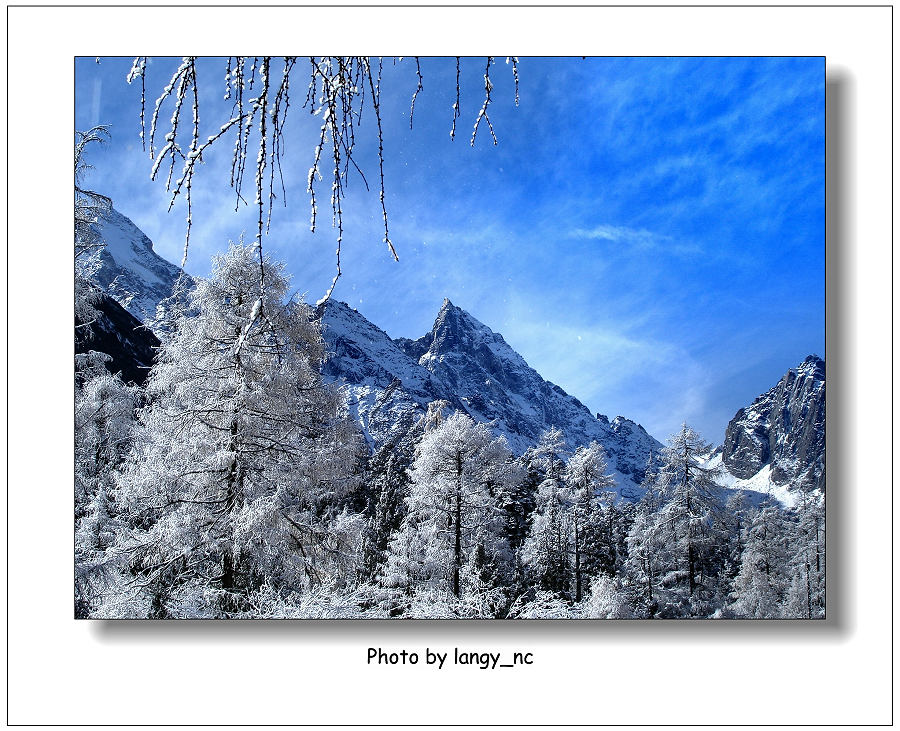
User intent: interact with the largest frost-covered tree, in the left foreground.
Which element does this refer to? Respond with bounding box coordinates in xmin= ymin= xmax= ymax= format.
xmin=115 ymin=244 xmax=358 ymax=615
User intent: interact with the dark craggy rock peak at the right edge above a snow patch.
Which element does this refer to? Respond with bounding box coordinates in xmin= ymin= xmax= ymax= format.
xmin=722 ymin=355 xmax=825 ymax=489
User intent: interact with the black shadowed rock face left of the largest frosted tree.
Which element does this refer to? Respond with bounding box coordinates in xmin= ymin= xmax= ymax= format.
xmin=75 ymin=294 xmax=159 ymax=386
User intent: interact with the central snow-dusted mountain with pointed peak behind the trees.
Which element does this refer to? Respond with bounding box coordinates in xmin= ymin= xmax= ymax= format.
xmin=319 ymin=300 xmax=662 ymax=498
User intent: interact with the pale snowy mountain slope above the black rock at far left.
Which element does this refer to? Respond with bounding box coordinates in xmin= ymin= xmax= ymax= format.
xmin=92 ymin=207 xmax=181 ymax=324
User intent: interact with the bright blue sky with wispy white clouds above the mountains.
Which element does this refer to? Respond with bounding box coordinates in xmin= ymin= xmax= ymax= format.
xmin=75 ymin=58 xmax=825 ymax=443
